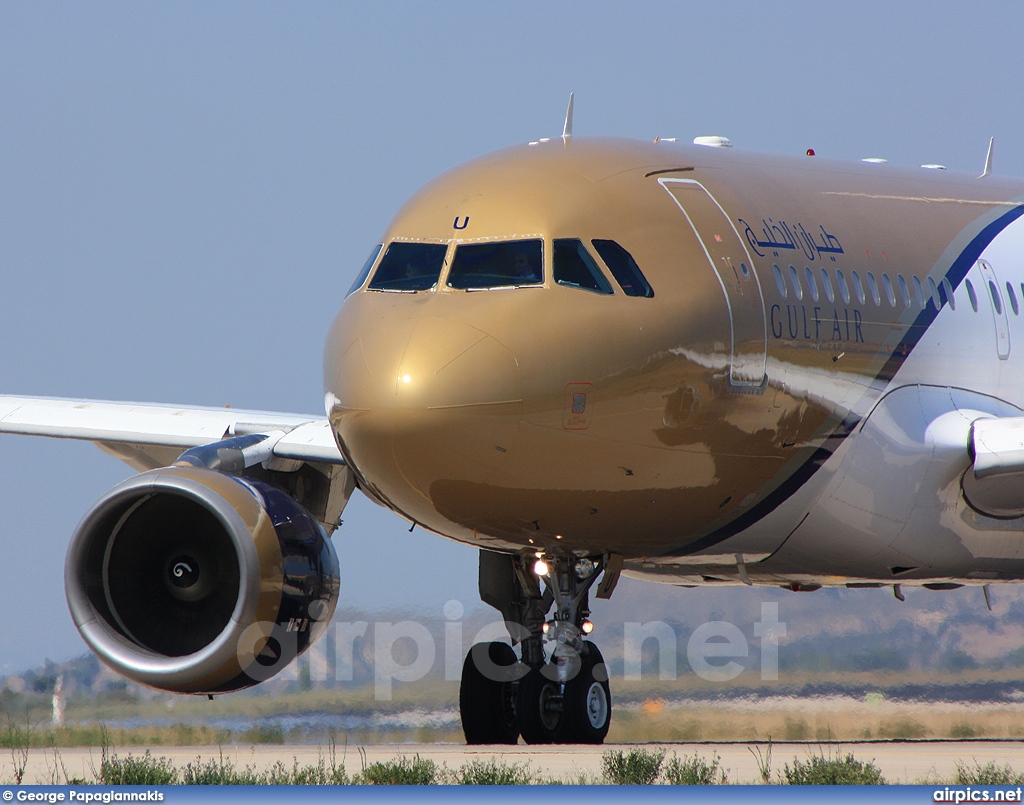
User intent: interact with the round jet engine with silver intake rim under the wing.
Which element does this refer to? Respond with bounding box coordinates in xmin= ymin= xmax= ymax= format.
xmin=65 ymin=467 xmax=340 ymax=693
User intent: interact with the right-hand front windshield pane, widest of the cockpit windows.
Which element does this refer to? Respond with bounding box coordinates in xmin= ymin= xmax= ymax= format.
xmin=447 ymin=240 xmax=544 ymax=291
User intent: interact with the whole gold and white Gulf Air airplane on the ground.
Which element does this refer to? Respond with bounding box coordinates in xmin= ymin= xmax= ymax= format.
xmin=0 ymin=101 xmax=1024 ymax=745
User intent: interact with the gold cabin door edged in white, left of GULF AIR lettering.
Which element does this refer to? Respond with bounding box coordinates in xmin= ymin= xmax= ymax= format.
xmin=658 ymin=179 xmax=768 ymax=389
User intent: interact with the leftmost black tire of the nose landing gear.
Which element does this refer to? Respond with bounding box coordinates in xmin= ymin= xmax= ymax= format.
xmin=459 ymin=642 xmax=521 ymax=745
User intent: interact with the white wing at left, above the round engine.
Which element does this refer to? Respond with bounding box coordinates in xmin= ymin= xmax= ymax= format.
xmin=0 ymin=395 xmax=345 ymax=470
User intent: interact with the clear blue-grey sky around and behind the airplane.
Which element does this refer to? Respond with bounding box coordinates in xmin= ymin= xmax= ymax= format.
xmin=0 ymin=0 xmax=1024 ymax=675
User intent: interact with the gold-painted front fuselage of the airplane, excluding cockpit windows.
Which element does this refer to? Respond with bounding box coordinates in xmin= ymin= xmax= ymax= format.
xmin=325 ymin=138 xmax=1022 ymax=559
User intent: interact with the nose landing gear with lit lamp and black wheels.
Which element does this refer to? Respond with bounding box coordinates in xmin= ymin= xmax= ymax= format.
xmin=459 ymin=551 xmax=617 ymax=744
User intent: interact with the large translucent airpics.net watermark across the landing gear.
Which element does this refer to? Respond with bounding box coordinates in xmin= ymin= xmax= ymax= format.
xmin=238 ymin=600 xmax=786 ymax=701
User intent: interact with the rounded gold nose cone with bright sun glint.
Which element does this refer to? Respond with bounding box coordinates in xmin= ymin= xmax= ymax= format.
xmin=331 ymin=319 xmax=522 ymax=515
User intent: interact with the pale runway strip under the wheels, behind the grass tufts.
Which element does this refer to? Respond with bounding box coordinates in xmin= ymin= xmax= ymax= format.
xmin=14 ymin=740 xmax=1024 ymax=783
